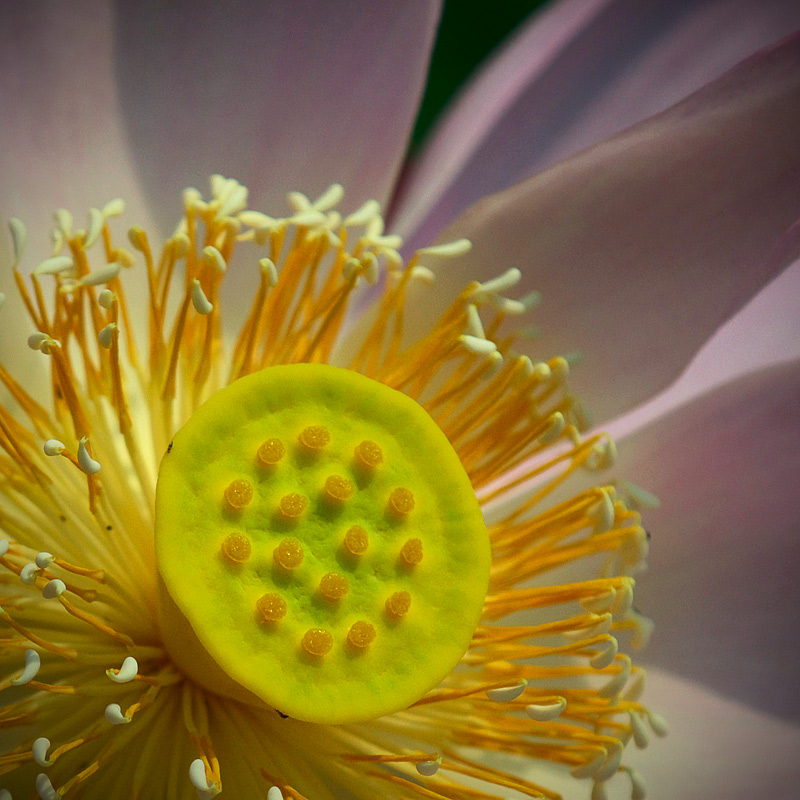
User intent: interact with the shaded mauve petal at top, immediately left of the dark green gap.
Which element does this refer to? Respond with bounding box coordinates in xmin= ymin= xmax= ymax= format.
xmin=115 ymin=0 xmax=439 ymax=228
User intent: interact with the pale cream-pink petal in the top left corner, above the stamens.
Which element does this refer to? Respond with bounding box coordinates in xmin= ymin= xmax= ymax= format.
xmin=0 ymin=0 xmax=155 ymax=363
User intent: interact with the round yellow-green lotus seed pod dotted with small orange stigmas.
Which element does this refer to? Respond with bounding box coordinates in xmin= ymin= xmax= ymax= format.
xmin=156 ymin=364 xmax=491 ymax=723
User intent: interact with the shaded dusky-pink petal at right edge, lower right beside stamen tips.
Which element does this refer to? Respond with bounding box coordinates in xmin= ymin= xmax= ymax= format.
xmin=616 ymin=361 xmax=800 ymax=720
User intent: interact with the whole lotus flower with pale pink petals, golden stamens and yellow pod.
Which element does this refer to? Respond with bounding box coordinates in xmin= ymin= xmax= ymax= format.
xmin=0 ymin=0 xmax=800 ymax=800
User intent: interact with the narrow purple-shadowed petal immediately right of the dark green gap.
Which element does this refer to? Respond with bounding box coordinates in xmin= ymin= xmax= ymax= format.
xmin=395 ymin=0 xmax=800 ymax=244
